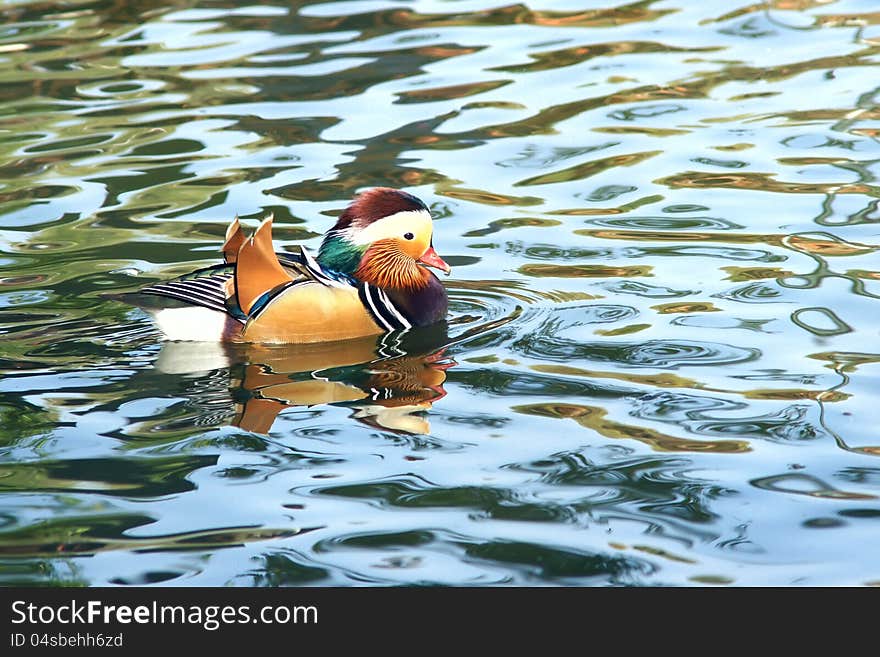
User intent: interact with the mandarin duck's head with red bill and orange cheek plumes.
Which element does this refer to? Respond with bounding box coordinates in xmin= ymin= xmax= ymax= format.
xmin=318 ymin=187 xmax=450 ymax=290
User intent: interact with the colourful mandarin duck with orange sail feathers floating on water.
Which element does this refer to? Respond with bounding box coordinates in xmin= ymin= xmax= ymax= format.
xmin=125 ymin=187 xmax=450 ymax=343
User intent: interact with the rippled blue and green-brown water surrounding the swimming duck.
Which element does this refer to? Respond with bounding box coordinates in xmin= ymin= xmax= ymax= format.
xmin=0 ymin=0 xmax=880 ymax=585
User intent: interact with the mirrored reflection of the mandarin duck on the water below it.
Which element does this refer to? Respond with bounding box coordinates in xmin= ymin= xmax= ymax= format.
xmin=156 ymin=323 xmax=456 ymax=434
